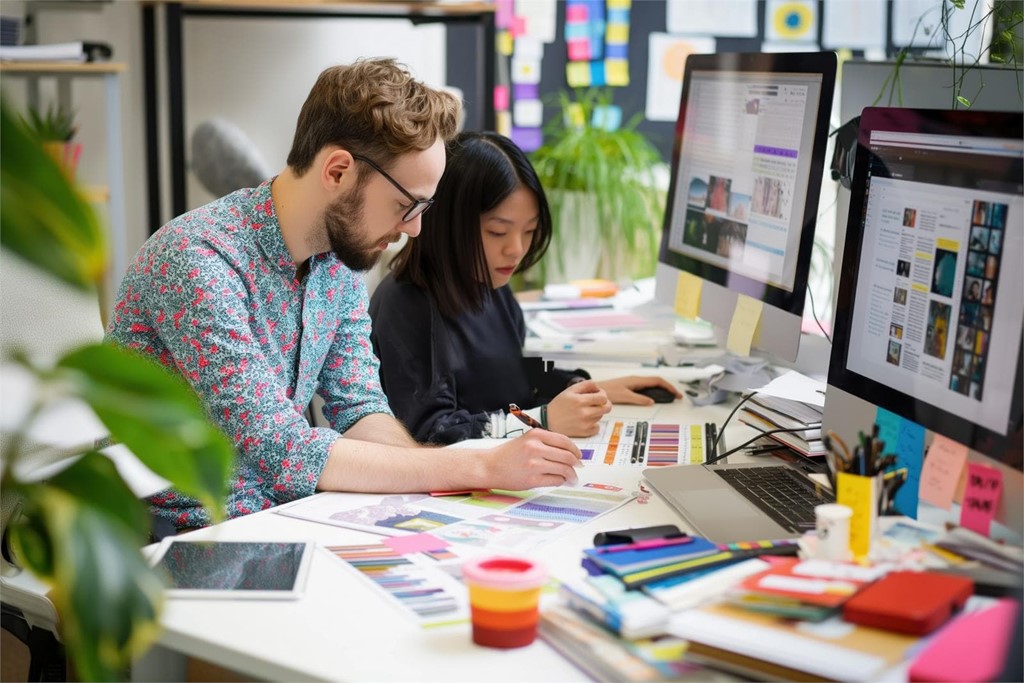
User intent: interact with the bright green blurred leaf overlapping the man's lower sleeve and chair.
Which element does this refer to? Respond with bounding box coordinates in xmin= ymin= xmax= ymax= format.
xmin=57 ymin=344 xmax=234 ymax=520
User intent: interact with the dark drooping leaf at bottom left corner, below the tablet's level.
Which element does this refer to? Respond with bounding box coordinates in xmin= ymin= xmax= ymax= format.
xmin=10 ymin=471 xmax=163 ymax=681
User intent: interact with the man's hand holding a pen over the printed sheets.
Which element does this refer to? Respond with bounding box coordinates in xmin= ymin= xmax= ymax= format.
xmin=479 ymin=429 xmax=581 ymax=490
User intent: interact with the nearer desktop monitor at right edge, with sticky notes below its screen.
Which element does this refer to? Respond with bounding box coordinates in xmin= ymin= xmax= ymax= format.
xmin=823 ymin=108 xmax=1024 ymax=531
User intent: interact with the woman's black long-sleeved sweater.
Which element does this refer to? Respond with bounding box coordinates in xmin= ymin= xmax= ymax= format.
xmin=370 ymin=275 xmax=587 ymax=443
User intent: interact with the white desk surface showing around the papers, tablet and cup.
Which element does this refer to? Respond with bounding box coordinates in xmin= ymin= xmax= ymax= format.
xmin=132 ymin=364 xmax=753 ymax=681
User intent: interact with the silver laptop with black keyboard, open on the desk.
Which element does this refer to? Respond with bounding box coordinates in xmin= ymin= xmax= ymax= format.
xmin=643 ymin=463 xmax=835 ymax=543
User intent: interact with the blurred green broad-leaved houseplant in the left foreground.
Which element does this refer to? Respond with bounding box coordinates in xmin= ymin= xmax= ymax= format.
xmin=0 ymin=100 xmax=233 ymax=680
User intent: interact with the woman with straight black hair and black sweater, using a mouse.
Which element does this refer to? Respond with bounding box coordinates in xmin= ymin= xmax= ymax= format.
xmin=370 ymin=132 xmax=681 ymax=443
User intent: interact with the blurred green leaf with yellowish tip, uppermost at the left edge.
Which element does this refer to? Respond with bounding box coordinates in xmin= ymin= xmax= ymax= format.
xmin=0 ymin=100 xmax=108 ymax=289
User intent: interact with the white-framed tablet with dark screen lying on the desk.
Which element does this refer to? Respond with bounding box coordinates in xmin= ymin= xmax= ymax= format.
xmin=153 ymin=538 xmax=313 ymax=600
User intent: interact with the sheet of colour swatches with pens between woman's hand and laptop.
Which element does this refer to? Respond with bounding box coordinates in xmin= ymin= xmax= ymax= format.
xmin=572 ymin=419 xmax=724 ymax=467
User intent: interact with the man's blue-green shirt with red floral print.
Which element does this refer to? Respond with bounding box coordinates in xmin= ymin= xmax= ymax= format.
xmin=106 ymin=180 xmax=391 ymax=528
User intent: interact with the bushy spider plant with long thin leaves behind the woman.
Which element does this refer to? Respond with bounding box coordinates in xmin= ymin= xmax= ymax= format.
xmin=530 ymin=88 xmax=665 ymax=282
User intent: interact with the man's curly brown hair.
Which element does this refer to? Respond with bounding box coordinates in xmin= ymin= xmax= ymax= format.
xmin=288 ymin=58 xmax=462 ymax=176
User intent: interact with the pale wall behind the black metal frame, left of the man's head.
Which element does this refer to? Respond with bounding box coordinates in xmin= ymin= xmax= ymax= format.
xmin=0 ymin=0 xmax=446 ymax=272
